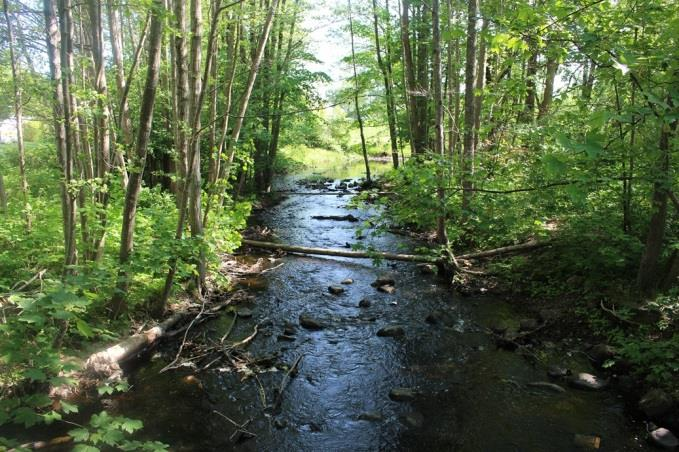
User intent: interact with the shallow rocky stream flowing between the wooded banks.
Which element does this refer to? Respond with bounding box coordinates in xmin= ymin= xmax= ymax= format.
xmin=109 ymin=165 xmax=648 ymax=452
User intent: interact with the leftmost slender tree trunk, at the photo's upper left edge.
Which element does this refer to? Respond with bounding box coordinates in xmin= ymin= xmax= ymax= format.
xmin=2 ymin=0 xmax=32 ymax=233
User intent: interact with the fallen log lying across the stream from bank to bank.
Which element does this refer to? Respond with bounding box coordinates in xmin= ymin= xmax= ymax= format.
xmin=242 ymin=239 xmax=549 ymax=264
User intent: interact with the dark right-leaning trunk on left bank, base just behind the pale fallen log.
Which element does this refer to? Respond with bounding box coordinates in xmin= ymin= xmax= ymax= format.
xmin=111 ymin=0 xmax=164 ymax=318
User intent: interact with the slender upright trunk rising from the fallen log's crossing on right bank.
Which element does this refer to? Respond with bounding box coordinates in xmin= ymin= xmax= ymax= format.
xmin=431 ymin=0 xmax=448 ymax=245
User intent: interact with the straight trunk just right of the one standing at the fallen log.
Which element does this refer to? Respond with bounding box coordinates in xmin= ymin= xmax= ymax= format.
xmin=462 ymin=0 xmax=478 ymax=211
